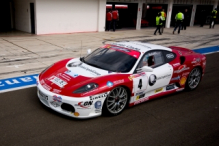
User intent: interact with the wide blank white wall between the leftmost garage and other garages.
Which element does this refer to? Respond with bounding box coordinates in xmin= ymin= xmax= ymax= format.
xmin=36 ymin=0 xmax=106 ymax=34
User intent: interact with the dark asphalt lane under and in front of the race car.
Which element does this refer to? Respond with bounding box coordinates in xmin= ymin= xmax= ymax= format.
xmin=0 ymin=53 xmax=219 ymax=146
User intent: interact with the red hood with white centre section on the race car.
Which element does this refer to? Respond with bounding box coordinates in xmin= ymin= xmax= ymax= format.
xmin=39 ymin=58 xmax=124 ymax=96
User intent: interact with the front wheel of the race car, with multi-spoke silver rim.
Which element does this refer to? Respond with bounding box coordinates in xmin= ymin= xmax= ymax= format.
xmin=103 ymin=86 xmax=128 ymax=116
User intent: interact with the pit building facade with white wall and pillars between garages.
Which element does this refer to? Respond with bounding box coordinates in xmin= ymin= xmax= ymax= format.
xmin=0 ymin=0 xmax=218 ymax=35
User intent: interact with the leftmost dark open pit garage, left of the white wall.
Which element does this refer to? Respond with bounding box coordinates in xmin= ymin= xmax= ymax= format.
xmin=0 ymin=0 xmax=35 ymax=34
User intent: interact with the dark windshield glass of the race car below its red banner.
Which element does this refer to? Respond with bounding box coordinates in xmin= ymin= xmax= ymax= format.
xmin=83 ymin=48 xmax=137 ymax=72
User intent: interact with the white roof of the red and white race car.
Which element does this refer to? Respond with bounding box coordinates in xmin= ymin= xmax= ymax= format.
xmin=111 ymin=41 xmax=172 ymax=52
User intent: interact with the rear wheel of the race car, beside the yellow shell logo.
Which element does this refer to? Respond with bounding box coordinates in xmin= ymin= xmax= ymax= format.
xmin=186 ymin=67 xmax=202 ymax=91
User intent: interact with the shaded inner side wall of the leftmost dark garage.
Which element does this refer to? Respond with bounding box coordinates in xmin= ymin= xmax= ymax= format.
xmin=14 ymin=0 xmax=35 ymax=33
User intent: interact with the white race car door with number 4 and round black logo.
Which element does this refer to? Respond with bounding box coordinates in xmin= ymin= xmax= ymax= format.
xmin=134 ymin=50 xmax=173 ymax=100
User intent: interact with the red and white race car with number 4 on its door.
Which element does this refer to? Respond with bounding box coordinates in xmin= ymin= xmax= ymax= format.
xmin=37 ymin=42 xmax=206 ymax=118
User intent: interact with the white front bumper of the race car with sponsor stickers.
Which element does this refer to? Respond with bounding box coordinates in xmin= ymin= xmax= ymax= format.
xmin=37 ymin=80 xmax=107 ymax=119
